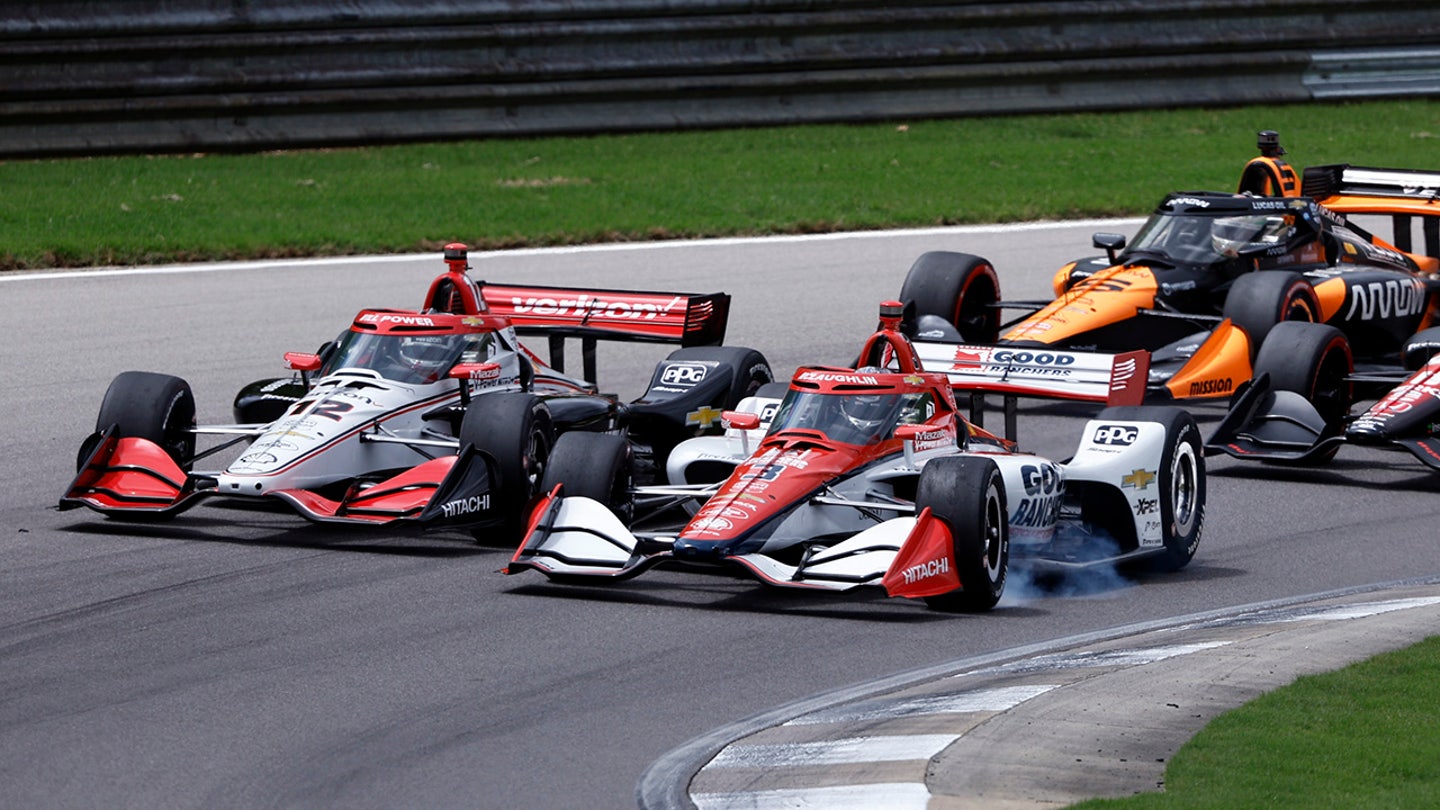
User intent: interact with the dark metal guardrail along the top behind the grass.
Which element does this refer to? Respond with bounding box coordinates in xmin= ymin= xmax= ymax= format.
xmin=0 ymin=0 xmax=1440 ymax=157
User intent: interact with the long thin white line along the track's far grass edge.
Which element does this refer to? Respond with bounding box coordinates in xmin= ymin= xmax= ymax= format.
xmin=0 ymin=218 xmax=1145 ymax=282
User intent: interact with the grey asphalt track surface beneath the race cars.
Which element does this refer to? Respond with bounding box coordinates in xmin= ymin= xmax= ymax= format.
xmin=0 ymin=222 xmax=1440 ymax=809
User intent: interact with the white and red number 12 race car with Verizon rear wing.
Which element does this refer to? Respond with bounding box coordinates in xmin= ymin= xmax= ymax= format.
xmin=59 ymin=244 xmax=772 ymax=536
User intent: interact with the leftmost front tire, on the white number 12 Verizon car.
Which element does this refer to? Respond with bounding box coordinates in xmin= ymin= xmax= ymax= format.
xmin=75 ymin=372 xmax=194 ymax=471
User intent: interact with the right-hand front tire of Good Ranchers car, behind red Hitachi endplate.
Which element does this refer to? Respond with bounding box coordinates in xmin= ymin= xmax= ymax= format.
xmin=914 ymin=455 xmax=1009 ymax=613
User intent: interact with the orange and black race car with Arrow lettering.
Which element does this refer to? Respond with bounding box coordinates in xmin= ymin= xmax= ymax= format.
xmin=900 ymin=131 xmax=1440 ymax=401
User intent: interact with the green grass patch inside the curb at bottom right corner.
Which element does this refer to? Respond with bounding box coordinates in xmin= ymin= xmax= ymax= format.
xmin=1074 ymin=638 xmax=1440 ymax=810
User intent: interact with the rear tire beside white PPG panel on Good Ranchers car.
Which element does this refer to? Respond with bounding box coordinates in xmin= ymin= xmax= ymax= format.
xmin=1096 ymin=405 xmax=1205 ymax=571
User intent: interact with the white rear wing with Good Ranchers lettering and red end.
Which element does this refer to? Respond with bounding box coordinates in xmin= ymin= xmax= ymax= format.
xmin=914 ymin=340 xmax=1151 ymax=440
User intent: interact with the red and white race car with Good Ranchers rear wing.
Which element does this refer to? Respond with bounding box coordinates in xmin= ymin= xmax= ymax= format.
xmin=507 ymin=301 xmax=1205 ymax=611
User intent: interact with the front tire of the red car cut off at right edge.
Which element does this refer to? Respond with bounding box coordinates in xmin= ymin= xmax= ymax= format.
xmin=1254 ymin=323 xmax=1355 ymax=464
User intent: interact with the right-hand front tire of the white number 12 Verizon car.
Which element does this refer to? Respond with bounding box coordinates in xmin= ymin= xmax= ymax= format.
xmin=459 ymin=392 xmax=554 ymax=543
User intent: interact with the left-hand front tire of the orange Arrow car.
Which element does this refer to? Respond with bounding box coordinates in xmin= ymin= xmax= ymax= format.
xmin=900 ymin=251 xmax=999 ymax=344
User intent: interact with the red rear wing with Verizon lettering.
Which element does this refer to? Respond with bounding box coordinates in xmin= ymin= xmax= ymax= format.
xmin=481 ymin=284 xmax=730 ymax=379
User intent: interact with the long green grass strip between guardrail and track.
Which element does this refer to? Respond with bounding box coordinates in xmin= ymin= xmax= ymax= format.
xmin=0 ymin=101 xmax=1440 ymax=268
